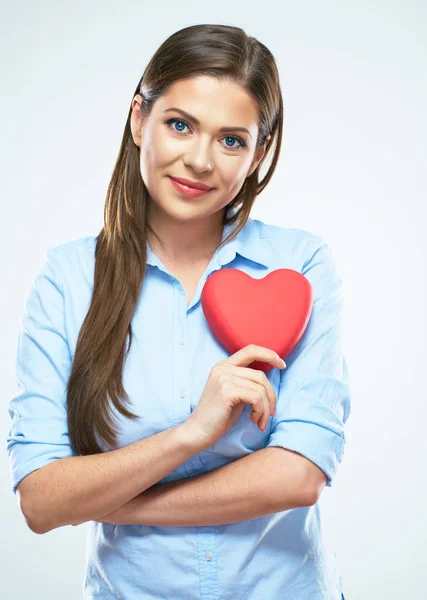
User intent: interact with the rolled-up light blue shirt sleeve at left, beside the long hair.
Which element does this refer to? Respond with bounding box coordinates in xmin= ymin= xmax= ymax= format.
xmin=6 ymin=249 xmax=78 ymax=494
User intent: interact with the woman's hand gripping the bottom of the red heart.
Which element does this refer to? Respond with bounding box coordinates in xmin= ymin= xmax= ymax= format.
xmin=183 ymin=344 xmax=286 ymax=449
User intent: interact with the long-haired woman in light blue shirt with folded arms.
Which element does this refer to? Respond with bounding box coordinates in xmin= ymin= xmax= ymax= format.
xmin=7 ymin=25 xmax=350 ymax=600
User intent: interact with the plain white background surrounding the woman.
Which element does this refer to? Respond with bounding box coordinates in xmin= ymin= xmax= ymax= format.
xmin=0 ymin=0 xmax=427 ymax=600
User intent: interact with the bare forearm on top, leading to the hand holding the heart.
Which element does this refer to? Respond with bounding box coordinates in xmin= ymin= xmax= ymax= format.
xmin=33 ymin=426 xmax=198 ymax=533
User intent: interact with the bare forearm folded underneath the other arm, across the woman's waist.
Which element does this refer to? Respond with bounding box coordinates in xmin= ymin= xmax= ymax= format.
xmin=99 ymin=447 xmax=309 ymax=527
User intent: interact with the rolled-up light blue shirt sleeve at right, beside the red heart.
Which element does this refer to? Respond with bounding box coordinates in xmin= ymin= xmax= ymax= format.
xmin=267 ymin=235 xmax=351 ymax=487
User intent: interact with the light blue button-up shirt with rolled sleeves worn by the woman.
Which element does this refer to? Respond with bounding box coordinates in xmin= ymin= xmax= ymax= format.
xmin=7 ymin=218 xmax=350 ymax=600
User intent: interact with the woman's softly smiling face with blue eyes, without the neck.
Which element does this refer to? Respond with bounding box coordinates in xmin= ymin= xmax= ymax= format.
xmin=131 ymin=76 xmax=265 ymax=220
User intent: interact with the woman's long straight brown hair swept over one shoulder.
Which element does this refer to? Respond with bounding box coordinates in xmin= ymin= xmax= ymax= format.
xmin=67 ymin=25 xmax=283 ymax=455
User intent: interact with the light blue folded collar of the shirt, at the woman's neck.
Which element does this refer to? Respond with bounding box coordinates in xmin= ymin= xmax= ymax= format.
xmin=147 ymin=217 xmax=269 ymax=267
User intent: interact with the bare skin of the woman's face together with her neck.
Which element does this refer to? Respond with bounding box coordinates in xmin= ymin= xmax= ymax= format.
xmin=131 ymin=75 xmax=271 ymax=262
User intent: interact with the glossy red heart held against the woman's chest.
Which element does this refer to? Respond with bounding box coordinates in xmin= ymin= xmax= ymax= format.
xmin=201 ymin=269 xmax=313 ymax=372
